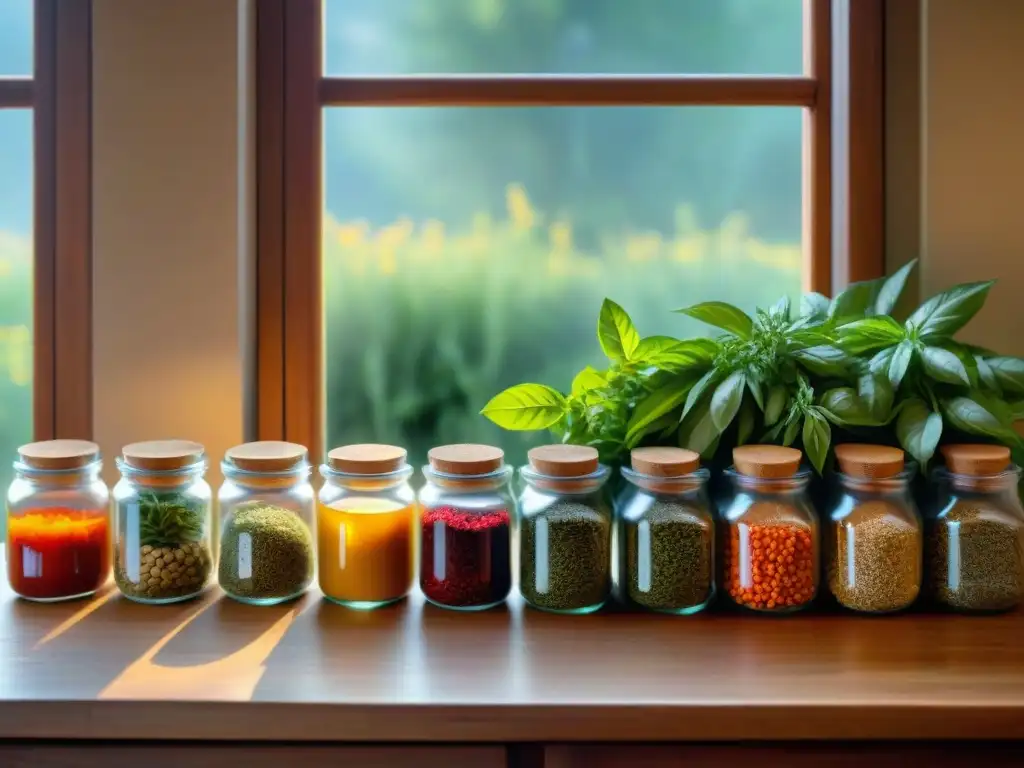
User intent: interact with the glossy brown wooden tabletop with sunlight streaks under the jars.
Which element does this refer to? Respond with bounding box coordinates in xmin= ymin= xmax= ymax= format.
xmin=0 ymin=588 xmax=1024 ymax=741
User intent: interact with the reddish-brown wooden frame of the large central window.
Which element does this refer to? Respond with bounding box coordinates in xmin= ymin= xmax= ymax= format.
xmin=256 ymin=0 xmax=886 ymax=457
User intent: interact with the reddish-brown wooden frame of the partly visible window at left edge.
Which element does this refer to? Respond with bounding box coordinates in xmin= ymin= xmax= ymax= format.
xmin=0 ymin=0 xmax=92 ymax=440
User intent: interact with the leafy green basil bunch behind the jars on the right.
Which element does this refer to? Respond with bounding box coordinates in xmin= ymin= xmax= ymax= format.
xmin=482 ymin=261 xmax=1024 ymax=472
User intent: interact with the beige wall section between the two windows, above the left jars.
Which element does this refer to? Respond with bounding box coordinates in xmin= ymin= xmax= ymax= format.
xmin=93 ymin=0 xmax=252 ymax=483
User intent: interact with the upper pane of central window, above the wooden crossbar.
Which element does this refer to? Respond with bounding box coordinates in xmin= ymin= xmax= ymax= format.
xmin=324 ymin=0 xmax=803 ymax=75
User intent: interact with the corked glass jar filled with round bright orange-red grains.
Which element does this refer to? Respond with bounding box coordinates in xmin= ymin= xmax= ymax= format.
xmin=721 ymin=445 xmax=818 ymax=613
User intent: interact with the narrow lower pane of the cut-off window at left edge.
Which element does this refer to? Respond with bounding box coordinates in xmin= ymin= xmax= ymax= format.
xmin=0 ymin=110 xmax=32 ymax=507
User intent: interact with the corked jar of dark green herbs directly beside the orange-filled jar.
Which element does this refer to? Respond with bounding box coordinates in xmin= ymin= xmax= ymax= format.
xmin=616 ymin=447 xmax=715 ymax=614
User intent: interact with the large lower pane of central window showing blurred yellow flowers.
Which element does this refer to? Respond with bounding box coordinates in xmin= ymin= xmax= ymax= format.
xmin=324 ymin=108 xmax=802 ymax=460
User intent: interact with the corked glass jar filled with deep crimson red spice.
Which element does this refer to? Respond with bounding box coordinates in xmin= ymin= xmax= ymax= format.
xmin=420 ymin=444 xmax=515 ymax=610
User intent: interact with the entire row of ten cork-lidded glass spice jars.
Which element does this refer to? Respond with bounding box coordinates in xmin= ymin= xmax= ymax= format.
xmin=7 ymin=440 xmax=1024 ymax=614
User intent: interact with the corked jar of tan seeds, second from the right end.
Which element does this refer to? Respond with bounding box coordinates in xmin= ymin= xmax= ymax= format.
xmin=824 ymin=443 xmax=924 ymax=613
